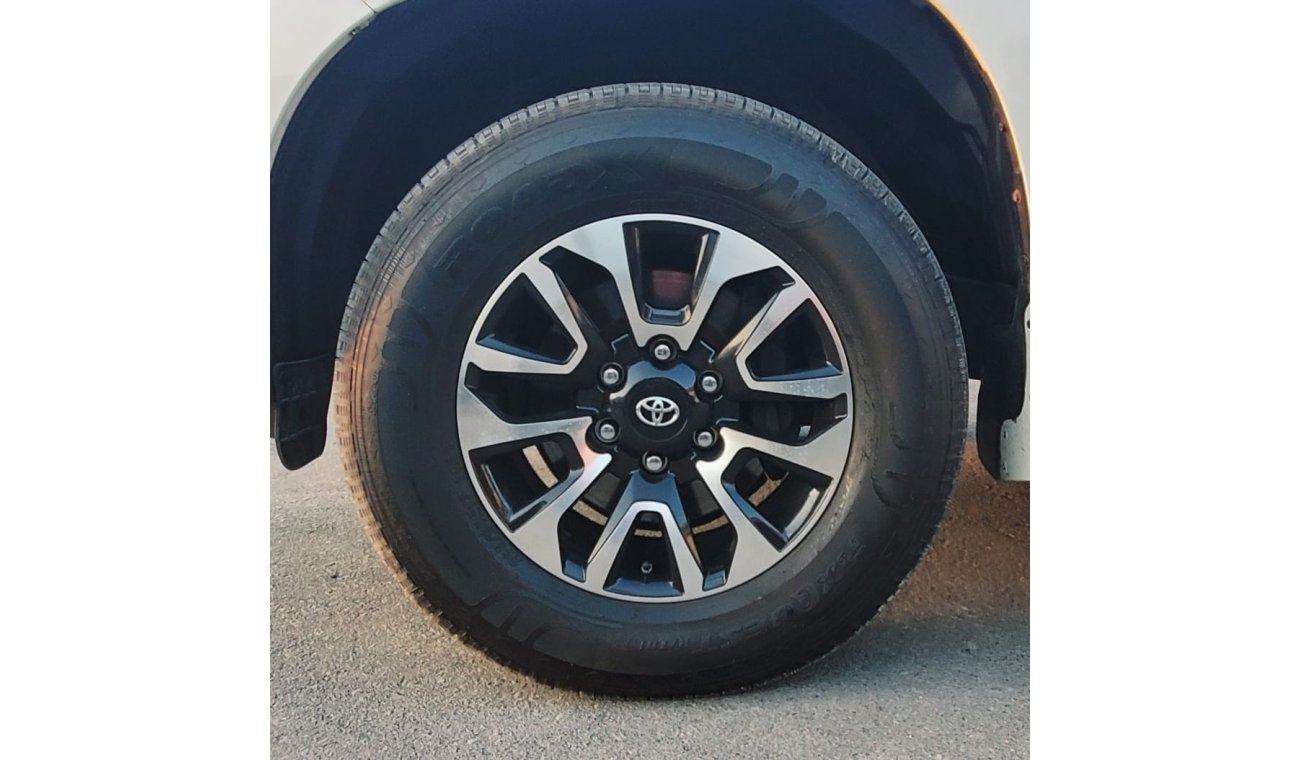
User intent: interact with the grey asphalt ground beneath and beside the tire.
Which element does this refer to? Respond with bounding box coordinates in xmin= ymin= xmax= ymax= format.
xmin=270 ymin=426 xmax=1030 ymax=759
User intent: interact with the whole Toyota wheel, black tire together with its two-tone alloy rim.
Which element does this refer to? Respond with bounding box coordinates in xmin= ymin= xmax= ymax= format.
xmin=337 ymin=83 xmax=966 ymax=695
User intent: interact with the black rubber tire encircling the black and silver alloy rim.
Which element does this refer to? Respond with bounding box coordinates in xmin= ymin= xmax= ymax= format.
xmin=335 ymin=83 xmax=967 ymax=696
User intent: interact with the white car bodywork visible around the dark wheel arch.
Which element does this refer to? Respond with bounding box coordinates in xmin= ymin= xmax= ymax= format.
xmin=270 ymin=0 xmax=1030 ymax=481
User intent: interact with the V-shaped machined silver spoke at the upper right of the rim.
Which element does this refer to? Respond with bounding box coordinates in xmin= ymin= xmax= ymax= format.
xmin=719 ymin=283 xmax=849 ymax=399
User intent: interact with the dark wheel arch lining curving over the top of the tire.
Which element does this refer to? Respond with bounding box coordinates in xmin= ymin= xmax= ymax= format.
xmin=270 ymin=0 xmax=1028 ymax=473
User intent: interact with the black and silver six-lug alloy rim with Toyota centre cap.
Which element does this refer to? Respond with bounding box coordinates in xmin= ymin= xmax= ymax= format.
xmin=456 ymin=214 xmax=853 ymax=603
